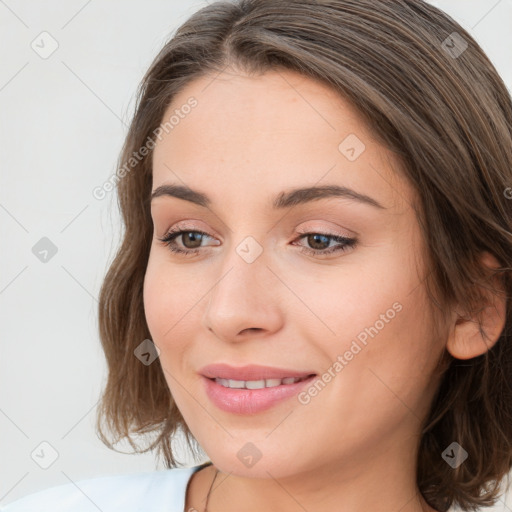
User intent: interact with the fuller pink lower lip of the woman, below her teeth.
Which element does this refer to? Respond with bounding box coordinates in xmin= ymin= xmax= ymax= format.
xmin=203 ymin=375 xmax=316 ymax=414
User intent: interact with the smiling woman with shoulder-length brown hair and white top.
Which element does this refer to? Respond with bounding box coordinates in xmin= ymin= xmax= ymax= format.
xmin=4 ymin=0 xmax=512 ymax=512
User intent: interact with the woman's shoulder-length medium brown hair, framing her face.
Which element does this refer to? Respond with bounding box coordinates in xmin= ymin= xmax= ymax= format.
xmin=97 ymin=0 xmax=512 ymax=510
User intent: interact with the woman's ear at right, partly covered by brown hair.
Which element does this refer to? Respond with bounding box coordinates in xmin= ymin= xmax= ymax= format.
xmin=446 ymin=252 xmax=506 ymax=359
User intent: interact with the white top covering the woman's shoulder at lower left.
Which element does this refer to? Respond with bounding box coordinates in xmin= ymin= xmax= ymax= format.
xmin=0 ymin=466 xmax=201 ymax=512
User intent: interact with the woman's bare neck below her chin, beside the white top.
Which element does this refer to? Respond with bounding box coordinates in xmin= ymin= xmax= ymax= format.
xmin=196 ymin=430 xmax=436 ymax=512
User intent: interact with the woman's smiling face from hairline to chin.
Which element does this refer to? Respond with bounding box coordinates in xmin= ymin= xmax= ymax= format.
xmin=144 ymin=71 xmax=443 ymax=478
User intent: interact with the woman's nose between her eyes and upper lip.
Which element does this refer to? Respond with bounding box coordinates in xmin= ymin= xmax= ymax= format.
xmin=203 ymin=246 xmax=284 ymax=342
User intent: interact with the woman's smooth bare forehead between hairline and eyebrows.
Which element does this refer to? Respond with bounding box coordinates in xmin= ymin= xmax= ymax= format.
xmin=153 ymin=70 xmax=411 ymax=212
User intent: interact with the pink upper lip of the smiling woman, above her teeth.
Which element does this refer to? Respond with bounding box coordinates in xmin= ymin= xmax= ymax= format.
xmin=199 ymin=363 xmax=316 ymax=380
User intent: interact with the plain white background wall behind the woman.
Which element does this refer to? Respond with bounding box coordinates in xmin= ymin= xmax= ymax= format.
xmin=0 ymin=0 xmax=512 ymax=511
